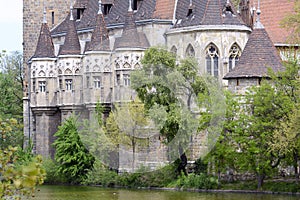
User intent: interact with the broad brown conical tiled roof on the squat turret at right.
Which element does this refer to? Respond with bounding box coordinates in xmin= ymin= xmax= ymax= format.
xmin=224 ymin=24 xmax=284 ymax=79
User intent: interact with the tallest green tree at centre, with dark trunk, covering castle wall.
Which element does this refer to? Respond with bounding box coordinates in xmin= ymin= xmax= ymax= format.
xmin=131 ymin=47 xmax=205 ymax=171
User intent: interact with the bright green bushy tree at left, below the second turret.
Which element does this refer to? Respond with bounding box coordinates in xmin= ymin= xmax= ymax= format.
xmin=53 ymin=116 xmax=95 ymax=183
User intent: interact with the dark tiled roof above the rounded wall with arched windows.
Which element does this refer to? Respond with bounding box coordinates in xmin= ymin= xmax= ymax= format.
xmin=174 ymin=0 xmax=245 ymax=28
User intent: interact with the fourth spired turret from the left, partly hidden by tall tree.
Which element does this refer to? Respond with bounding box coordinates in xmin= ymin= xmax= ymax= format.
xmin=114 ymin=0 xmax=150 ymax=102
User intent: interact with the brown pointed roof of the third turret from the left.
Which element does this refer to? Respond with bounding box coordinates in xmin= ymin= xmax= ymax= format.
xmin=86 ymin=11 xmax=110 ymax=51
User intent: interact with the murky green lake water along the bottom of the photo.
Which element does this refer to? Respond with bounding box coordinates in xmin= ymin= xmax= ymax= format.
xmin=33 ymin=186 xmax=300 ymax=200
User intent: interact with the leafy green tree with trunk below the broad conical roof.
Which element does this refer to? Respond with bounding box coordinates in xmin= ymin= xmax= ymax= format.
xmin=235 ymin=80 xmax=290 ymax=189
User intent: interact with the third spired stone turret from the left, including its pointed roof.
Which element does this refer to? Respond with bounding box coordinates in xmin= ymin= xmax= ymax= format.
xmin=83 ymin=0 xmax=113 ymax=111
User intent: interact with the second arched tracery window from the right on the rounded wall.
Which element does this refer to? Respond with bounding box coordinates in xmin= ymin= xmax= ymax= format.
xmin=206 ymin=44 xmax=219 ymax=77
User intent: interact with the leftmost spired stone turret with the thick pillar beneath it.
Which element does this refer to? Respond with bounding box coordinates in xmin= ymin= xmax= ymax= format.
xmin=24 ymin=7 xmax=60 ymax=157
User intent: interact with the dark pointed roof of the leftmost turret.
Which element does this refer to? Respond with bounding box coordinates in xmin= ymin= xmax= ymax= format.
xmin=32 ymin=23 xmax=55 ymax=58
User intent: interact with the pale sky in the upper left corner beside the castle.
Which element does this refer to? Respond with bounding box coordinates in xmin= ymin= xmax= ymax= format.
xmin=0 ymin=0 xmax=23 ymax=52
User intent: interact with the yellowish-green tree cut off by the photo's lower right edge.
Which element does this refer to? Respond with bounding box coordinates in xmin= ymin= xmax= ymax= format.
xmin=270 ymin=61 xmax=300 ymax=179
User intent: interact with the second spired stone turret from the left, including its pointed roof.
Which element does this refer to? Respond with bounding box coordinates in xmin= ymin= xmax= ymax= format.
xmin=58 ymin=4 xmax=83 ymax=120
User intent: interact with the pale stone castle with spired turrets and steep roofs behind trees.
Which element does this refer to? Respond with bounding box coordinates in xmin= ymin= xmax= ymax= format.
xmin=24 ymin=0 xmax=292 ymax=172
